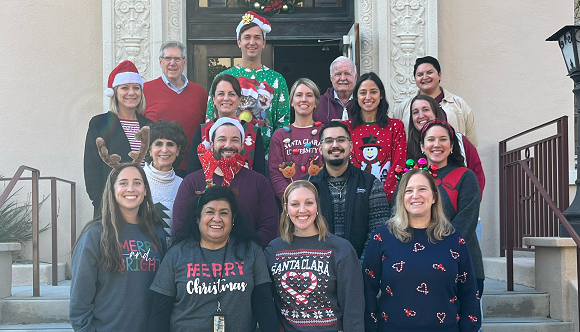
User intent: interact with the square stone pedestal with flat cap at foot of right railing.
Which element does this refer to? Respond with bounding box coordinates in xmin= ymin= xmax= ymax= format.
xmin=523 ymin=237 xmax=578 ymax=321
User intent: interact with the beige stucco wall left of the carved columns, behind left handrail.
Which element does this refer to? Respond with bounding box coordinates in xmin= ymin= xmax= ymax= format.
xmin=0 ymin=0 xmax=102 ymax=261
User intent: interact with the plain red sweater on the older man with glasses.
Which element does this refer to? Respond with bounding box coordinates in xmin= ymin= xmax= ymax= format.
xmin=143 ymin=77 xmax=207 ymax=170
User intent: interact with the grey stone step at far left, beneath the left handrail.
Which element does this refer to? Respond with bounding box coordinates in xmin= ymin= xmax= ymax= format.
xmin=0 ymin=280 xmax=70 ymax=324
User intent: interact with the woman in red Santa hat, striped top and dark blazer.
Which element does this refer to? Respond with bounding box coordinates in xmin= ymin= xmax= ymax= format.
xmin=84 ymin=60 xmax=152 ymax=216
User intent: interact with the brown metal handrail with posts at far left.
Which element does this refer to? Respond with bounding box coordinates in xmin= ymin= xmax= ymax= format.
xmin=0 ymin=165 xmax=76 ymax=296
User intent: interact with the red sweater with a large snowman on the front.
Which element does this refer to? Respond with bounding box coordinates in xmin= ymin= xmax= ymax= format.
xmin=344 ymin=119 xmax=407 ymax=202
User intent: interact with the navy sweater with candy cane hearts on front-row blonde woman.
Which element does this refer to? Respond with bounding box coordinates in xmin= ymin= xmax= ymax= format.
xmin=363 ymin=225 xmax=481 ymax=332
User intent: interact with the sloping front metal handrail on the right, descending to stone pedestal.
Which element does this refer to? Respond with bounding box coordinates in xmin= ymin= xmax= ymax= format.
xmin=504 ymin=160 xmax=580 ymax=322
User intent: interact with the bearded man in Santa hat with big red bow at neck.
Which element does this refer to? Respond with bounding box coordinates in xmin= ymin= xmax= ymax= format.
xmin=173 ymin=117 xmax=280 ymax=248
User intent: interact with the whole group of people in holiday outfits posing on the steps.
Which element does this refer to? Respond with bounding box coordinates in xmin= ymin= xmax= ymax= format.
xmin=70 ymin=12 xmax=485 ymax=332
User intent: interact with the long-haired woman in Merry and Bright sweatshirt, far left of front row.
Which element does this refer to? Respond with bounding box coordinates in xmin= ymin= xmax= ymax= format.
xmin=70 ymin=163 xmax=167 ymax=331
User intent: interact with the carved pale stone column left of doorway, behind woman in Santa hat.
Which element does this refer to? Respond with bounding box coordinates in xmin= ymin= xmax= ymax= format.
xmin=102 ymin=0 xmax=186 ymax=112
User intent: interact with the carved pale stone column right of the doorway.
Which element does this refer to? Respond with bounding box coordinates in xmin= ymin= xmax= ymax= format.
xmin=358 ymin=0 xmax=438 ymax=107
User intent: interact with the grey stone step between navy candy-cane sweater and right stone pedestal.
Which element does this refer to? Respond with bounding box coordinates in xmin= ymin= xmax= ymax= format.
xmin=482 ymin=278 xmax=550 ymax=318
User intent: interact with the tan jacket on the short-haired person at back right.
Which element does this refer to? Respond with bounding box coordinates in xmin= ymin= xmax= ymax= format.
xmin=389 ymin=87 xmax=477 ymax=147
